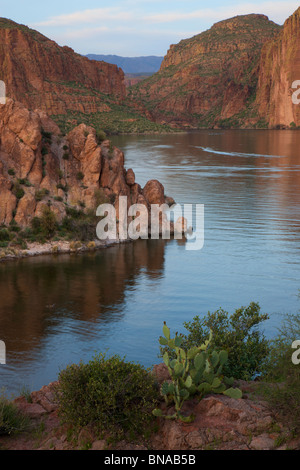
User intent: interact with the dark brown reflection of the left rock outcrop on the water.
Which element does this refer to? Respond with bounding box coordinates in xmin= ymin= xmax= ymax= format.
xmin=0 ymin=240 xmax=167 ymax=353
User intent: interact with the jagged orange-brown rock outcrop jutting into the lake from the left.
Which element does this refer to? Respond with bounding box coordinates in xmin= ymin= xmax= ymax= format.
xmin=0 ymin=99 xmax=171 ymax=232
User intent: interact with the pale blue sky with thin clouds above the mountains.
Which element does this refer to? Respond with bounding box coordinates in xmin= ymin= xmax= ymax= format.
xmin=0 ymin=0 xmax=300 ymax=57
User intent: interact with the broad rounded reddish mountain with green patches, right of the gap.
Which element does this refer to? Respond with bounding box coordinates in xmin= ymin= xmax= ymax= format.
xmin=130 ymin=14 xmax=281 ymax=128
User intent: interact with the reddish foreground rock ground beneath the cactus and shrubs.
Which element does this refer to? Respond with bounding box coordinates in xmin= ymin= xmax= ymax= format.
xmin=0 ymin=365 xmax=300 ymax=451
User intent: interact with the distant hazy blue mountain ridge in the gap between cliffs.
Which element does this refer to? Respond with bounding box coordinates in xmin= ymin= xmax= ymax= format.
xmin=86 ymin=54 xmax=163 ymax=74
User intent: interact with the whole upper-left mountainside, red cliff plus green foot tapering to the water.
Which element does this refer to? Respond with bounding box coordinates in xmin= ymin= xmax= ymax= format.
xmin=0 ymin=18 xmax=173 ymax=134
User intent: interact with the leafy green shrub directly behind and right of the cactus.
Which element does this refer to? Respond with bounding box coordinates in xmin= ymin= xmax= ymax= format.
xmin=161 ymin=302 xmax=270 ymax=380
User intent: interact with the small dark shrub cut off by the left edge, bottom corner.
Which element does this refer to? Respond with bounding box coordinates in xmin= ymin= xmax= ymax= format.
xmin=0 ymin=396 xmax=29 ymax=435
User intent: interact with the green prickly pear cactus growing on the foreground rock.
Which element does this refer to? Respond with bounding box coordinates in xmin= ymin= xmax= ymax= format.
xmin=153 ymin=323 xmax=242 ymax=422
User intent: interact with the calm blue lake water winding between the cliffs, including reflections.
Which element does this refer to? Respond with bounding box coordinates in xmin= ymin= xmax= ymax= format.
xmin=0 ymin=131 xmax=300 ymax=394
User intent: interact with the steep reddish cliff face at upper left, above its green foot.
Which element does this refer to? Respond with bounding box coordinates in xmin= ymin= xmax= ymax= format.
xmin=0 ymin=18 xmax=125 ymax=115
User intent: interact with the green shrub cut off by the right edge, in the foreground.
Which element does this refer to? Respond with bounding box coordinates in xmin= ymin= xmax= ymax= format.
xmin=263 ymin=313 xmax=300 ymax=432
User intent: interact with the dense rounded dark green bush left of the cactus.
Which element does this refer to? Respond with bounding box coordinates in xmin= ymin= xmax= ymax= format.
xmin=57 ymin=354 xmax=157 ymax=438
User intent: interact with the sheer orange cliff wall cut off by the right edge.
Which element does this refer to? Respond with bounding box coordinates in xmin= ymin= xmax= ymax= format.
xmin=256 ymin=8 xmax=300 ymax=127
